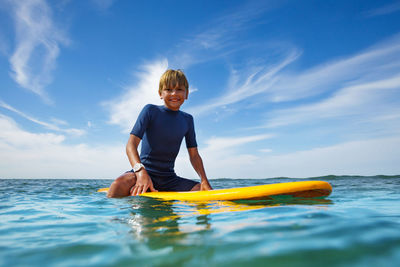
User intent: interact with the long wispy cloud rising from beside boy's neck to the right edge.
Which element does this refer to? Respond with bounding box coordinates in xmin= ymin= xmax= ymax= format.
xmin=190 ymin=31 xmax=400 ymax=118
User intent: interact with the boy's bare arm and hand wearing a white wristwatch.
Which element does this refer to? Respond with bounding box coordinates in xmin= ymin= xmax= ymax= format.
xmin=126 ymin=134 xmax=157 ymax=196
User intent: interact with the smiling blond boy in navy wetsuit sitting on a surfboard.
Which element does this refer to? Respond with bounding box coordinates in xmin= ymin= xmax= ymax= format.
xmin=107 ymin=70 xmax=212 ymax=197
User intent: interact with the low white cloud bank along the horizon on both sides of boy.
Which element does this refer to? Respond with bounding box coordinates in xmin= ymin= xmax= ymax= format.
xmin=0 ymin=115 xmax=400 ymax=179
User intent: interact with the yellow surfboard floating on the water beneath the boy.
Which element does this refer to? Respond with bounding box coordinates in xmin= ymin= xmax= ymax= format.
xmin=97 ymin=181 xmax=332 ymax=201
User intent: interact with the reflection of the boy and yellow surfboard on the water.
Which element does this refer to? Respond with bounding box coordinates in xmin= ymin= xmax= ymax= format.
xmin=128 ymin=196 xmax=333 ymax=245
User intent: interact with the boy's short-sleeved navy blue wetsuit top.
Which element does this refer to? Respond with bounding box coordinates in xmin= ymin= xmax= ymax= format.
xmin=131 ymin=104 xmax=197 ymax=176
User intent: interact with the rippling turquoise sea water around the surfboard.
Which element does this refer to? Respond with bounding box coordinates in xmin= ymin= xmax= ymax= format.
xmin=0 ymin=176 xmax=400 ymax=266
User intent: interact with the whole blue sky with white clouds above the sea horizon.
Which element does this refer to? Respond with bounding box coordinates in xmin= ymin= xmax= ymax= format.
xmin=0 ymin=0 xmax=400 ymax=179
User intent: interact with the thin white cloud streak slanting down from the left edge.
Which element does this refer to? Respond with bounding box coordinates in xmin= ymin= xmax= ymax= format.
xmin=0 ymin=100 xmax=86 ymax=136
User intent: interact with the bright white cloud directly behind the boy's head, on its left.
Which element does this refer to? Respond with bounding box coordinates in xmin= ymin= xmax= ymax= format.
xmin=103 ymin=59 xmax=168 ymax=132
